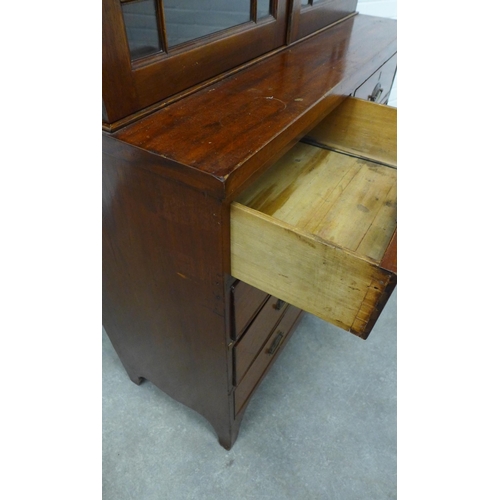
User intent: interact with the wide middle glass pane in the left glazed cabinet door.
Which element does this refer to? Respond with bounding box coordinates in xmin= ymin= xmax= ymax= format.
xmin=163 ymin=0 xmax=251 ymax=47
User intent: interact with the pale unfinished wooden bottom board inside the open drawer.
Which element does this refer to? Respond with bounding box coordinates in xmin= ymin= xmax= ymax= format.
xmin=238 ymin=143 xmax=397 ymax=262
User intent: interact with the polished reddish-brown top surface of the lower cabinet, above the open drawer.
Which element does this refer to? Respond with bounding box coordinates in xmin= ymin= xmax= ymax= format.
xmin=112 ymin=15 xmax=396 ymax=197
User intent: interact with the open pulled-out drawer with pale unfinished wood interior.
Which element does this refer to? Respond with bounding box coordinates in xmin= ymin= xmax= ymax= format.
xmin=231 ymin=98 xmax=397 ymax=338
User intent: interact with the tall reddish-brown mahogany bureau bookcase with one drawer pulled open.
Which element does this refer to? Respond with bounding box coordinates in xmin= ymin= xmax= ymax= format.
xmin=102 ymin=0 xmax=396 ymax=449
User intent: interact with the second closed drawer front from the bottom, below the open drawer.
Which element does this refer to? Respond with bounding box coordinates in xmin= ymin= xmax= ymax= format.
xmin=234 ymin=297 xmax=288 ymax=385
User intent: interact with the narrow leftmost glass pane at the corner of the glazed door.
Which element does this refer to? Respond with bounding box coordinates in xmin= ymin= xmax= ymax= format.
xmin=122 ymin=0 xmax=161 ymax=60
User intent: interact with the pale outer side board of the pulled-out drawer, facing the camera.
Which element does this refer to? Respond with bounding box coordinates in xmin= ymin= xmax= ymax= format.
xmin=231 ymin=202 xmax=393 ymax=338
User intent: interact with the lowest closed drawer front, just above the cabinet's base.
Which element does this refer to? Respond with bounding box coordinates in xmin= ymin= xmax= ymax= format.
xmin=234 ymin=306 xmax=302 ymax=415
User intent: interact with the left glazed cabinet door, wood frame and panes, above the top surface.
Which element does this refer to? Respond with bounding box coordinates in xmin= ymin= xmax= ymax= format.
xmin=102 ymin=0 xmax=287 ymax=123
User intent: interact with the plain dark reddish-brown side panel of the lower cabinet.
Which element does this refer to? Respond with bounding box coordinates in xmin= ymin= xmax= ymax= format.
xmin=103 ymin=138 xmax=230 ymax=430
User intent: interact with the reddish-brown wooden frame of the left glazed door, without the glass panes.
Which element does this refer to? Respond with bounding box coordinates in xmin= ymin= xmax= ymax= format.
xmin=102 ymin=0 xmax=287 ymax=122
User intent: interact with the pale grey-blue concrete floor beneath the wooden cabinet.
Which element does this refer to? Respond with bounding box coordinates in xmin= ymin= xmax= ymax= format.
xmin=103 ymin=291 xmax=396 ymax=500
